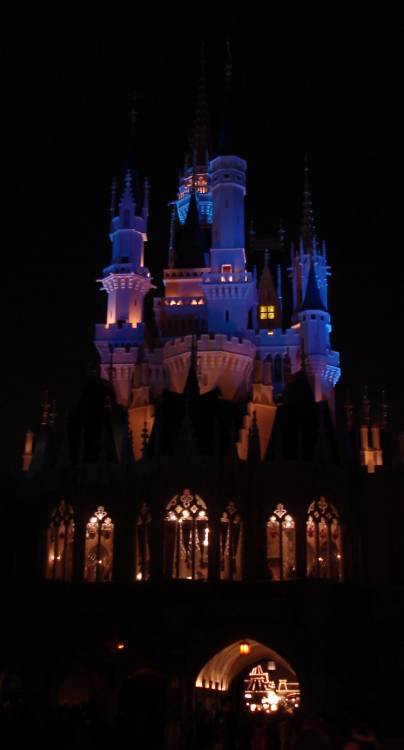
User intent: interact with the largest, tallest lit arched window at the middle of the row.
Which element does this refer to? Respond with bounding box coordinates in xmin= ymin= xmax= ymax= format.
xmin=164 ymin=490 xmax=209 ymax=580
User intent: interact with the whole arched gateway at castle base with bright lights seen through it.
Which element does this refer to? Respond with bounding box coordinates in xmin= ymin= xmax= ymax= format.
xmin=195 ymin=638 xmax=300 ymax=748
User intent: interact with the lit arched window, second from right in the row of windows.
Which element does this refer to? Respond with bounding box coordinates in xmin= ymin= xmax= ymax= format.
xmin=267 ymin=503 xmax=296 ymax=581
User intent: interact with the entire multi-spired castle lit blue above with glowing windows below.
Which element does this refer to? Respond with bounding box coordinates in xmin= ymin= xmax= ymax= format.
xmin=3 ymin=60 xmax=404 ymax=747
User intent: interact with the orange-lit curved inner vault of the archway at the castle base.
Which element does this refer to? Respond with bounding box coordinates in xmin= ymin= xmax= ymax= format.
xmin=195 ymin=638 xmax=296 ymax=691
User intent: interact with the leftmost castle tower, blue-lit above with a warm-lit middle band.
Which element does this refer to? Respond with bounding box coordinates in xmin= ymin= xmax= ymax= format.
xmin=94 ymin=171 xmax=152 ymax=405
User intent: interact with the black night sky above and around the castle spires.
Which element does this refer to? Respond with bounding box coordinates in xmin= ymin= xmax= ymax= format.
xmin=1 ymin=17 xmax=404 ymax=469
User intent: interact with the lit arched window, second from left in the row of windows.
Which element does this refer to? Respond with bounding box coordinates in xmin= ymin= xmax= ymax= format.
xmin=84 ymin=505 xmax=114 ymax=582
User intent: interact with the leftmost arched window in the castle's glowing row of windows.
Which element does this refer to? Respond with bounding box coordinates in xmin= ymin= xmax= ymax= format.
xmin=45 ymin=500 xmax=74 ymax=581
